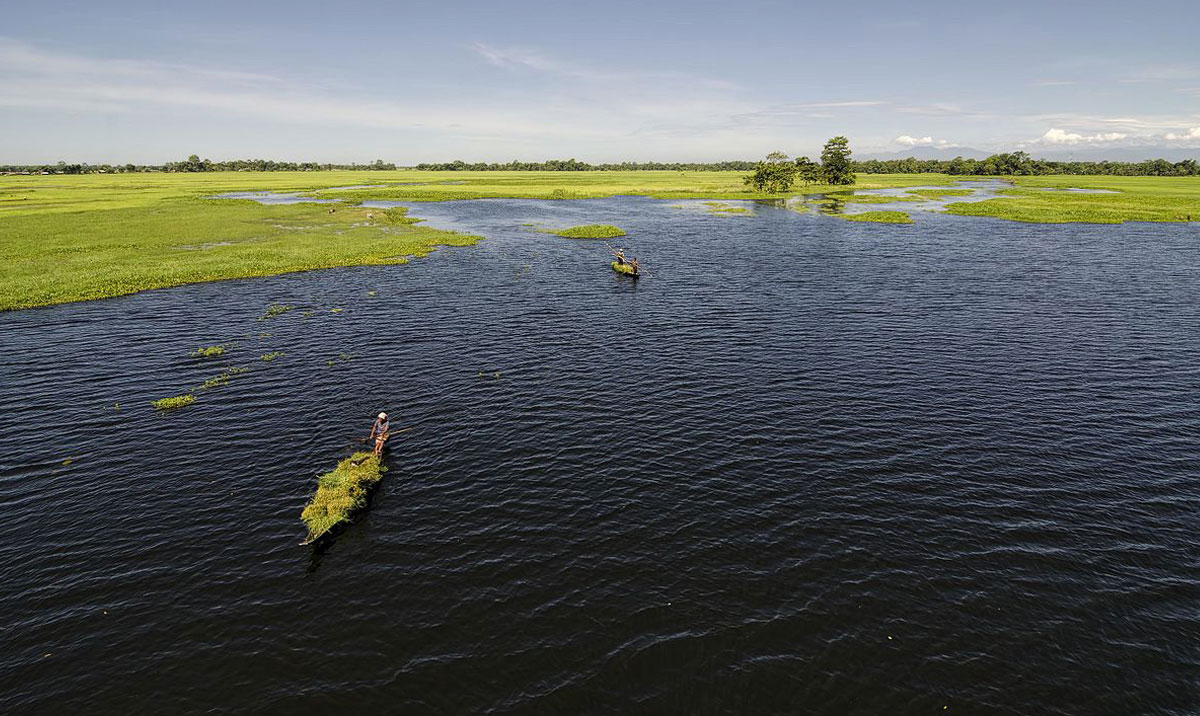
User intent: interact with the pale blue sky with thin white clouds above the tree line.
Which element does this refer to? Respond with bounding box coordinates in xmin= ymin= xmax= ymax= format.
xmin=0 ymin=0 xmax=1200 ymax=166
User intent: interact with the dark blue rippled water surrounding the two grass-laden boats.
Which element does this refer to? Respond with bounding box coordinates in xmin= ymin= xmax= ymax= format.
xmin=0 ymin=198 xmax=1200 ymax=715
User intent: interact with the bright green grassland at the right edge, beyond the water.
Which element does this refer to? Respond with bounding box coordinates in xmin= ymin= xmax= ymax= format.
xmin=946 ymin=176 xmax=1200 ymax=223
